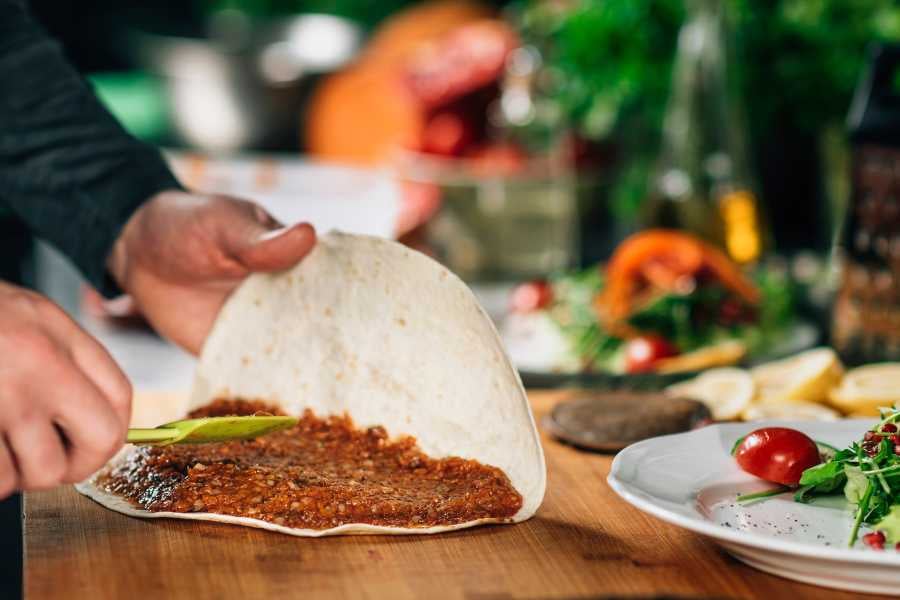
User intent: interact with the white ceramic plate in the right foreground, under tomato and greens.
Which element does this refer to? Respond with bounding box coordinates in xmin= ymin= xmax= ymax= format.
xmin=608 ymin=419 xmax=900 ymax=595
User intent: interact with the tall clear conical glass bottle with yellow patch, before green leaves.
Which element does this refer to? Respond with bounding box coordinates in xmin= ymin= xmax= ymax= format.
xmin=643 ymin=0 xmax=766 ymax=263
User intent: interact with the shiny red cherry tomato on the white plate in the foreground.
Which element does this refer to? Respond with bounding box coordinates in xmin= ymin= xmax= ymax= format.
xmin=733 ymin=427 xmax=822 ymax=485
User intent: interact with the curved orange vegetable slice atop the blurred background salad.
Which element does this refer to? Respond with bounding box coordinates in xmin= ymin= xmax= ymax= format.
xmin=595 ymin=229 xmax=760 ymax=321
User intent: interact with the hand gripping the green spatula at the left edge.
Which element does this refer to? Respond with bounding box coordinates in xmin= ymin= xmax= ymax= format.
xmin=0 ymin=283 xmax=131 ymax=498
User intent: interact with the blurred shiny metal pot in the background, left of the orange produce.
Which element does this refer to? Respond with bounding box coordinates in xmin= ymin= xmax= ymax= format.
xmin=130 ymin=11 xmax=363 ymax=152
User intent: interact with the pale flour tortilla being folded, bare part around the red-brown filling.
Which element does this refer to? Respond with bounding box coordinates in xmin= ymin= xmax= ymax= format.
xmin=76 ymin=232 xmax=546 ymax=536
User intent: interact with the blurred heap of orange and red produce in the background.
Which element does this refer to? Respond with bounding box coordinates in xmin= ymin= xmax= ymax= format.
xmin=305 ymin=2 xmax=519 ymax=164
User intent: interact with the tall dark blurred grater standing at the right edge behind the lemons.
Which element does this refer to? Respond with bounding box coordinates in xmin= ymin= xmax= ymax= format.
xmin=831 ymin=45 xmax=900 ymax=365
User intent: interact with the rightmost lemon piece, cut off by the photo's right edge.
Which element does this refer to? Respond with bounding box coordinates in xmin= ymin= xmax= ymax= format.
xmin=829 ymin=363 xmax=900 ymax=416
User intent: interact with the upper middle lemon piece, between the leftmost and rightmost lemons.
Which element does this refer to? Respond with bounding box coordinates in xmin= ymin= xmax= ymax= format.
xmin=750 ymin=348 xmax=843 ymax=404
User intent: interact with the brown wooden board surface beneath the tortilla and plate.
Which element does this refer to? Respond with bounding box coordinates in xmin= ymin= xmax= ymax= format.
xmin=24 ymin=392 xmax=873 ymax=600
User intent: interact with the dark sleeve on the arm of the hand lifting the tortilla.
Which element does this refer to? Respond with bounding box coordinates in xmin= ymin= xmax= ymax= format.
xmin=0 ymin=0 xmax=181 ymax=295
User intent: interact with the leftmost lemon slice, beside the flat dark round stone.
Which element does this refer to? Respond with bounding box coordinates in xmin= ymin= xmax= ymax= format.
xmin=666 ymin=367 xmax=756 ymax=421
